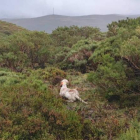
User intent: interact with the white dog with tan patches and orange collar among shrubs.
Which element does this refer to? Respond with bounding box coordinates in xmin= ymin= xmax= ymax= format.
xmin=59 ymin=79 xmax=87 ymax=104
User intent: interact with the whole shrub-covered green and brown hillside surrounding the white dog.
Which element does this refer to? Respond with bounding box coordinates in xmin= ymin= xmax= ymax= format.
xmin=0 ymin=18 xmax=140 ymax=140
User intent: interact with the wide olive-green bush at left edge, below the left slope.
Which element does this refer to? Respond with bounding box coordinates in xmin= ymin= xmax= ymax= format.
xmin=0 ymin=31 xmax=51 ymax=71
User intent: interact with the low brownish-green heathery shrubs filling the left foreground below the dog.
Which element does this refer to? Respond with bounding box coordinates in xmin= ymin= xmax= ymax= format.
xmin=0 ymin=79 xmax=93 ymax=140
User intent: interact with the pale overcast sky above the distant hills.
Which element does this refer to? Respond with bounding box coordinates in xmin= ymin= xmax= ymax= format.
xmin=0 ymin=0 xmax=140 ymax=18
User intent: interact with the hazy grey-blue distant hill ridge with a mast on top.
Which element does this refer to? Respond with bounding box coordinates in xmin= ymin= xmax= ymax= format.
xmin=2 ymin=14 xmax=139 ymax=33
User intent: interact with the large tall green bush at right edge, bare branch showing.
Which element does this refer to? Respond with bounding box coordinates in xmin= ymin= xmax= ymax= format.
xmin=88 ymin=19 xmax=140 ymax=103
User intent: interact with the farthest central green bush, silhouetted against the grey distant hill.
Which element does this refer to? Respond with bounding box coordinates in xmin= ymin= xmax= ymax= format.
xmin=51 ymin=26 xmax=104 ymax=47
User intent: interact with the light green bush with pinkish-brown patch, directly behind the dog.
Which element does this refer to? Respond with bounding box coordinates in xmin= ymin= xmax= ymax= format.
xmin=56 ymin=40 xmax=98 ymax=73
